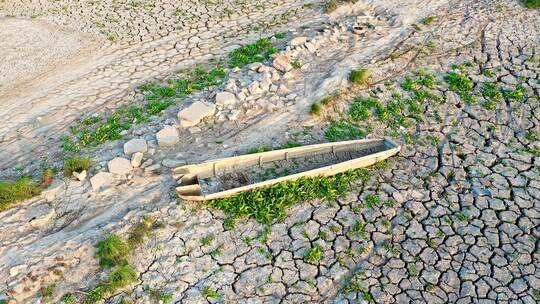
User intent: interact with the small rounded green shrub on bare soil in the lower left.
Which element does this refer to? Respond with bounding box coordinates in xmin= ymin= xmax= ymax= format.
xmin=97 ymin=234 xmax=130 ymax=268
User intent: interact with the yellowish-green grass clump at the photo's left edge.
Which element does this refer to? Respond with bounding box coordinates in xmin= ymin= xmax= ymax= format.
xmin=0 ymin=177 xmax=41 ymax=212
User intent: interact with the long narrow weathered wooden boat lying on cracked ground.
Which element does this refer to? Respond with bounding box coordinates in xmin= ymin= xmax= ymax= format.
xmin=173 ymin=138 xmax=401 ymax=201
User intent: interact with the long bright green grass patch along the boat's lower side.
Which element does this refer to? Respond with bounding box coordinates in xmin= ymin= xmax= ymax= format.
xmin=208 ymin=169 xmax=371 ymax=224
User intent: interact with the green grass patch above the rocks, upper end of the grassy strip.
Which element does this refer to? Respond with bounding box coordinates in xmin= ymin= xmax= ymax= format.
xmin=229 ymin=38 xmax=277 ymax=68
